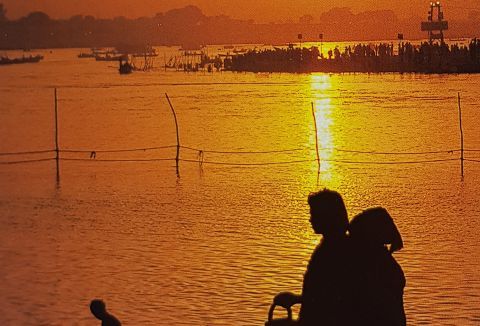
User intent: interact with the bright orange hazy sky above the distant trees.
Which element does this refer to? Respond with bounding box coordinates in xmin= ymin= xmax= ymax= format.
xmin=0 ymin=0 xmax=480 ymax=22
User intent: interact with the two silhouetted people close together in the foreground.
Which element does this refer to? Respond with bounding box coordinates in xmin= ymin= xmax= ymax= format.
xmin=274 ymin=189 xmax=406 ymax=326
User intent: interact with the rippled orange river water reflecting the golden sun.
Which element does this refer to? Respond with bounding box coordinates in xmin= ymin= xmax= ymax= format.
xmin=0 ymin=49 xmax=480 ymax=325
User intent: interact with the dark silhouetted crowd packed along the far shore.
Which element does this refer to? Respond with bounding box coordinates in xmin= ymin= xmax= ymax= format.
xmin=224 ymin=39 xmax=480 ymax=73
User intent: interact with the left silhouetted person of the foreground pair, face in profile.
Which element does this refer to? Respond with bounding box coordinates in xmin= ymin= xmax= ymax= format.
xmin=274 ymin=189 xmax=354 ymax=326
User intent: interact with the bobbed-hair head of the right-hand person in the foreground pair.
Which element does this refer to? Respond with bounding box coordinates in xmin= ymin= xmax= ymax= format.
xmin=349 ymin=207 xmax=403 ymax=252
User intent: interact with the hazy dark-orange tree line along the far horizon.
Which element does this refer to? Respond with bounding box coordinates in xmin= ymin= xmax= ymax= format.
xmin=0 ymin=4 xmax=480 ymax=49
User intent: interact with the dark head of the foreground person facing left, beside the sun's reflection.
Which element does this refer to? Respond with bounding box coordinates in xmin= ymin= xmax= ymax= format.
xmin=308 ymin=189 xmax=348 ymax=237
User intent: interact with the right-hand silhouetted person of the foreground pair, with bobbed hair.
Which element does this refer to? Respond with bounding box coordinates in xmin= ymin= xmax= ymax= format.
xmin=349 ymin=207 xmax=406 ymax=326
